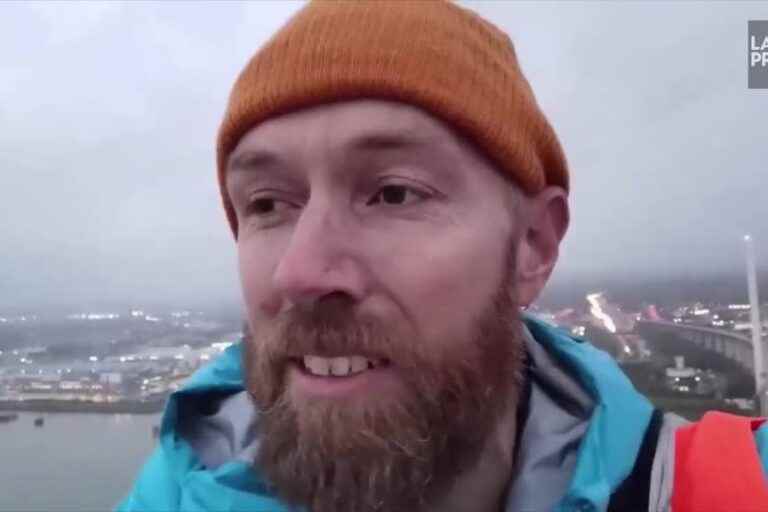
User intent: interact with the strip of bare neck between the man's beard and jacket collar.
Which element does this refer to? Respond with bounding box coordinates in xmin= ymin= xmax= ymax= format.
xmin=428 ymin=396 xmax=517 ymax=512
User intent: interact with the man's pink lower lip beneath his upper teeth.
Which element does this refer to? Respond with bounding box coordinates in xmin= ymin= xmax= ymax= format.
xmin=287 ymin=362 xmax=398 ymax=398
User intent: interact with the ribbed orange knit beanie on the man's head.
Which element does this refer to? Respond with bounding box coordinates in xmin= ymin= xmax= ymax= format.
xmin=217 ymin=0 xmax=568 ymax=235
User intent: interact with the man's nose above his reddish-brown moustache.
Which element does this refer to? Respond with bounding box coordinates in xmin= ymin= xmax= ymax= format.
xmin=273 ymin=205 xmax=365 ymax=306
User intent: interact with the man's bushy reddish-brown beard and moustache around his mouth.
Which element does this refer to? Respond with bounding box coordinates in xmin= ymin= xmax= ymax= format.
xmin=244 ymin=280 xmax=524 ymax=512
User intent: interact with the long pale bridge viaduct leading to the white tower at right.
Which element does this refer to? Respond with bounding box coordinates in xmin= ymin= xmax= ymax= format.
xmin=636 ymin=320 xmax=754 ymax=374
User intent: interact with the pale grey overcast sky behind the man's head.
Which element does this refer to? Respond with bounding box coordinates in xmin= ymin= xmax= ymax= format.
xmin=0 ymin=1 xmax=768 ymax=312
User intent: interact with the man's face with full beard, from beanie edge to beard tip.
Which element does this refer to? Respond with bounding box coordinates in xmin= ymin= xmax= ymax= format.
xmin=227 ymin=100 xmax=521 ymax=511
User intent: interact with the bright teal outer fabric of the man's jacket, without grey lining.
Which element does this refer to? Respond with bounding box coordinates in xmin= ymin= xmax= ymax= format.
xmin=117 ymin=317 xmax=768 ymax=512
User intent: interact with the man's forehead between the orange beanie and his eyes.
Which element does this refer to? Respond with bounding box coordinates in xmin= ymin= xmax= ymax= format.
xmin=229 ymin=100 xmax=474 ymax=167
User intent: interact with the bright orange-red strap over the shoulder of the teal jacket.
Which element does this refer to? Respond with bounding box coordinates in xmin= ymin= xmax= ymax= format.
xmin=672 ymin=412 xmax=768 ymax=512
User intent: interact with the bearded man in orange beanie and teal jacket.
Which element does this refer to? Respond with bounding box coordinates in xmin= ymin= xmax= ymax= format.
xmin=120 ymin=1 xmax=768 ymax=512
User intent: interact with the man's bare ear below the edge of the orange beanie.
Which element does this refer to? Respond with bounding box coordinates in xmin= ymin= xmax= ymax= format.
xmin=515 ymin=187 xmax=570 ymax=307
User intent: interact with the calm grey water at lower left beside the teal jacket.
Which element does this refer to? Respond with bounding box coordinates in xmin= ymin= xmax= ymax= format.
xmin=0 ymin=413 xmax=160 ymax=512
